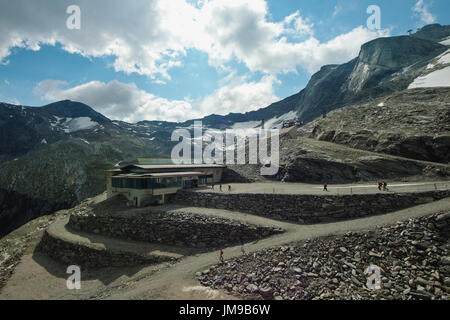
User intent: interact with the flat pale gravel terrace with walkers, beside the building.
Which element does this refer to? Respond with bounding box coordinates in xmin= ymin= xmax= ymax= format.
xmin=196 ymin=181 xmax=450 ymax=195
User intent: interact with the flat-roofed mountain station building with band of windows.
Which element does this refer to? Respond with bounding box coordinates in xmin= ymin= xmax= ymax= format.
xmin=106 ymin=159 xmax=226 ymax=207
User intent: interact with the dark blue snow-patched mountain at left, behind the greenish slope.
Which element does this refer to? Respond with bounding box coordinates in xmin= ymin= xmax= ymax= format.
xmin=0 ymin=100 xmax=174 ymax=163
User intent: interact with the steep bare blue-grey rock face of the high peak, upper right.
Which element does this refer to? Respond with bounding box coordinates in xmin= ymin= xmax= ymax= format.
xmin=296 ymin=34 xmax=450 ymax=122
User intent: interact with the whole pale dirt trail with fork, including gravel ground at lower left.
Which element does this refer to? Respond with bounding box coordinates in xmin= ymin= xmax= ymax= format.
xmin=0 ymin=192 xmax=450 ymax=300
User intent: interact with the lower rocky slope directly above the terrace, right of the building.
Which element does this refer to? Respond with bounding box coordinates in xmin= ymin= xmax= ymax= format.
xmin=224 ymin=136 xmax=450 ymax=184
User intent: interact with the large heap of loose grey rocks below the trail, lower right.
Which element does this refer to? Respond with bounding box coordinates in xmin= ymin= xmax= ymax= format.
xmin=197 ymin=212 xmax=450 ymax=300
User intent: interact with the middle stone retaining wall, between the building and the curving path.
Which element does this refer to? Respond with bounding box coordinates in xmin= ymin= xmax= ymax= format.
xmin=69 ymin=212 xmax=283 ymax=248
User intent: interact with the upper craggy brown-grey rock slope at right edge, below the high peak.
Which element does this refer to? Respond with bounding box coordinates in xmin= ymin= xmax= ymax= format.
xmin=309 ymin=88 xmax=450 ymax=163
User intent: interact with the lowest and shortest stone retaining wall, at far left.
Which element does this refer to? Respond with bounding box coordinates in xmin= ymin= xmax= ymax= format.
xmin=37 ymin=231 xmax=172 ymax=269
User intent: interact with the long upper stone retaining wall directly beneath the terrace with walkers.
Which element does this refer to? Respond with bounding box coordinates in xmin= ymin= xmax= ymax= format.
xmin=170 ymin=190 xmax=449 ymax=224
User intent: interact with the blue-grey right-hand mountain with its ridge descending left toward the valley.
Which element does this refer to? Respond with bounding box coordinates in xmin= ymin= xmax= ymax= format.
xmin=180 ymin=24 xmax=450 ymax=128
